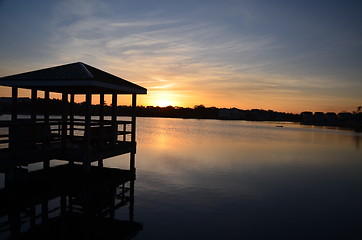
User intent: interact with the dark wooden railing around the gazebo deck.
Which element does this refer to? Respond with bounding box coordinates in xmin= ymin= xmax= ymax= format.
xmin=0 ymin=119 xmax=132 ymax=149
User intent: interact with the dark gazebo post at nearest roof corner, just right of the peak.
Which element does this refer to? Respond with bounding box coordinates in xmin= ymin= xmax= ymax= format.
xmin=83 ymin=89 xmax=92 ymax=172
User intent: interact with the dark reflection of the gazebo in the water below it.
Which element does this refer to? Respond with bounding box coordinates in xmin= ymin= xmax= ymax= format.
xmin=0 ymin=164 xmax=142 ymax=239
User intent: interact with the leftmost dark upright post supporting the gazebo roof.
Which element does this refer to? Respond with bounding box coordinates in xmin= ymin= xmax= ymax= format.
xmin=9 ymin=87 xmax=18 ymax=151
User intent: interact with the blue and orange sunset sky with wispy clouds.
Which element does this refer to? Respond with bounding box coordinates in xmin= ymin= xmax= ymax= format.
xmin=0 ymin=0 xmax=362 ymax=113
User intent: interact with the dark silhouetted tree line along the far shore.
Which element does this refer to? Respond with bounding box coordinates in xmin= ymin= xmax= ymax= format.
xmin=0 ymin=98 xmax=362 ymax=129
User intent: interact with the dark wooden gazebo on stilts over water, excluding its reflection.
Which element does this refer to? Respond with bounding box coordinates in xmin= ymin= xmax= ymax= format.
xmin=0 ymin=62 xmax=147 ymax=170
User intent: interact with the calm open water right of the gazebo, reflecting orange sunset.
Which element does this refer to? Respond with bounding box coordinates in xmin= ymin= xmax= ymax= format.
xmin=105 ymin=118 xmax=362 ymax=239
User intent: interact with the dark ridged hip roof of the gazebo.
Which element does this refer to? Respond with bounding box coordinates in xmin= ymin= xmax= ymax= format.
xmin=0 ymin=62 xmax=147 ymax=94
